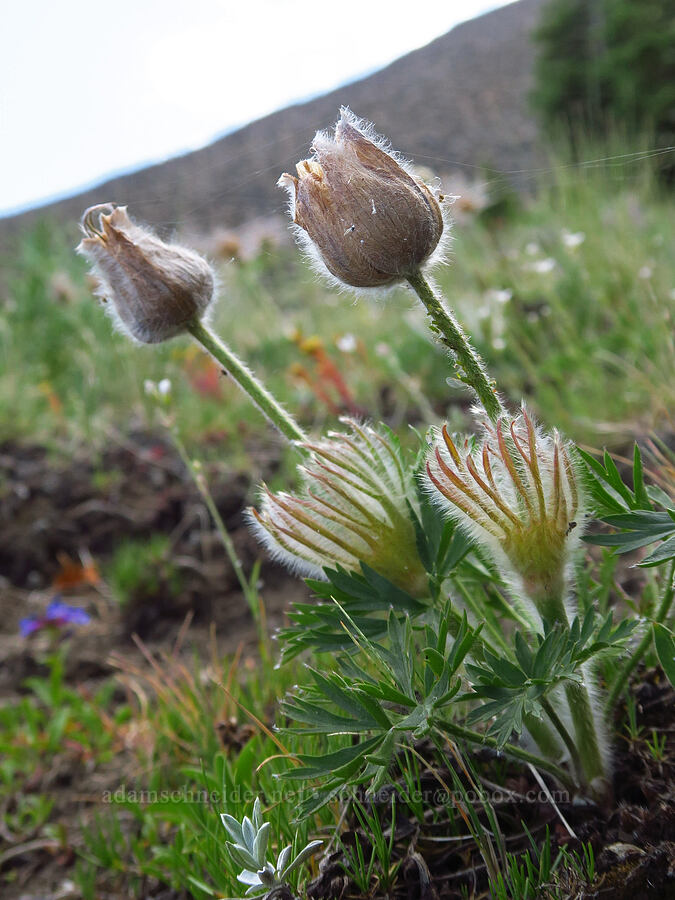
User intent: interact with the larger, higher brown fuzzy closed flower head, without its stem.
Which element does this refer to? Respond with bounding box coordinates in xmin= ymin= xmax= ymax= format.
xmin=279 ymin=109 xmax=444 ymax=288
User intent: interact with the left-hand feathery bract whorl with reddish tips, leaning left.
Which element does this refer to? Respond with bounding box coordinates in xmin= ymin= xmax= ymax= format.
xmin=250 ymin=419 xmax=427 ymax=597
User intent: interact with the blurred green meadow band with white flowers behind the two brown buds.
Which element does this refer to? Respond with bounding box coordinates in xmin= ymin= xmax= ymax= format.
xmin=0 ymin=144 xmax=675 ymax=466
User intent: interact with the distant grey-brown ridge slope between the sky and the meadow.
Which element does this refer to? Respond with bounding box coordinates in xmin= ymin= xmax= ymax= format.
xmin=0 ymin=0 xmax=545 ymax=245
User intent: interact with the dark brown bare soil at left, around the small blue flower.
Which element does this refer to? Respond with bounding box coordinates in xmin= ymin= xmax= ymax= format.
xmin=0 ymin=434 xmax=307 ymax=900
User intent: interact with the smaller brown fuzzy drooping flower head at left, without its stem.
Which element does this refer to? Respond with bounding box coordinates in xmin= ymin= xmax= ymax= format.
xmin=77 ymin=204 xmax=215 ymax=344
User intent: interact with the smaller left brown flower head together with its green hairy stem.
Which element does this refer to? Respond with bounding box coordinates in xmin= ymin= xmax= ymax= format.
xmin=77 ymin=203 xmax=305 ymax=441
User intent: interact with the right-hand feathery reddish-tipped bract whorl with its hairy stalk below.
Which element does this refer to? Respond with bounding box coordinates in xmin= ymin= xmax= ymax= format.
xmin=425 ymin=407 xmax=607 ymax=791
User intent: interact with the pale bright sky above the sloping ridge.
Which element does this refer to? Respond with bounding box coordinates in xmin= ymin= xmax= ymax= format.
xmin=0 ymin=0 xmax=503 ymax=215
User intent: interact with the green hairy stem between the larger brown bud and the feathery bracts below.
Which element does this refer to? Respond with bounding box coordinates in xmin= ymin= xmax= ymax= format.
xmin=407 ymin=270 xmax=504 ymax=422
